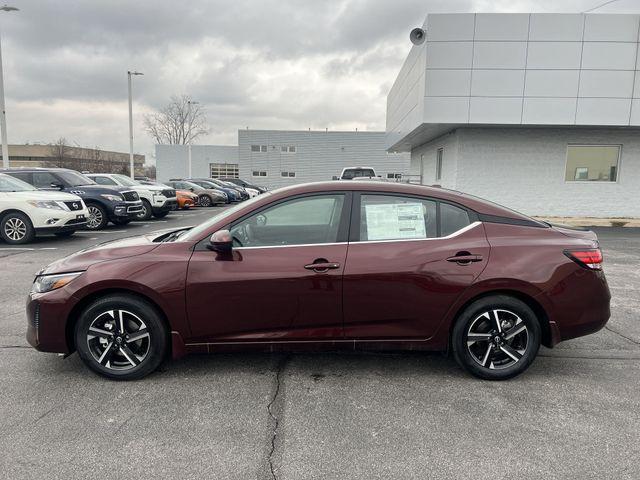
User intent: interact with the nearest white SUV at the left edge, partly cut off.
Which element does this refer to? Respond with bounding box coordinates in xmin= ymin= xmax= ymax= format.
xmin=0 ymin=173 xmax=89 ymax=244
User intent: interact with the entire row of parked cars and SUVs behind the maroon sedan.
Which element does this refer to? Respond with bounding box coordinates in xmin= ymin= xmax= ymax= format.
xmin=0 ymin=168 xmax=266 ymax=244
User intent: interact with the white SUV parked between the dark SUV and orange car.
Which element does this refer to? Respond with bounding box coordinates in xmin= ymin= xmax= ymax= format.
xmin=86 ymin=173 xmax=178 ymax=220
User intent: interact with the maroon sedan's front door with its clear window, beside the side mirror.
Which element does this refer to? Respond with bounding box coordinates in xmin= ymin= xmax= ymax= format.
xmin=186 ymin=192 xmax=351 ymax=341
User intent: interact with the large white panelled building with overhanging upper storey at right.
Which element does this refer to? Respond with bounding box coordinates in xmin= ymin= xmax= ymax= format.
xmin=386 ymin=14 xmax=640 ymax=217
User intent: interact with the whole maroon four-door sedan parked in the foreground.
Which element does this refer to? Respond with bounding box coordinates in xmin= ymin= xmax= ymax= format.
xmin=27 ymin=181 xmax=610 ymax=379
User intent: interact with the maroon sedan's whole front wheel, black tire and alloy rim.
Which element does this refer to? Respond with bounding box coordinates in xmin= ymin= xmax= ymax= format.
xmin=74 ymin=294 xmax=169 ymax=380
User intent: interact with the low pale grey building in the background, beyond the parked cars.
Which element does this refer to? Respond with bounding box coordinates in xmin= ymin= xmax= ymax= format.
xmin=156 ymin=130 xmax=409 ymax=188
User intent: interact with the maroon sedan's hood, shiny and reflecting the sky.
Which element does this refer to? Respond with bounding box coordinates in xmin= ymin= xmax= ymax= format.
xmin=38 ymin=232 xmax=164 ymax=275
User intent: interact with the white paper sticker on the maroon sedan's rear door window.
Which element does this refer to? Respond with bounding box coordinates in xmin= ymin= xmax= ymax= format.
xmin=365 ymin=203 xmax=427 ymax=240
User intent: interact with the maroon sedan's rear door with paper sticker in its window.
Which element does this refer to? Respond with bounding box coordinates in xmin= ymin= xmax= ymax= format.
xmin=343 ymin=193 xmax=489 ymax=339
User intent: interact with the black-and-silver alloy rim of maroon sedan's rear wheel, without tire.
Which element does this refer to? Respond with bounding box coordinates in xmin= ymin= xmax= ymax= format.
xmin=466 ymin=309 xmax=529 ymax=370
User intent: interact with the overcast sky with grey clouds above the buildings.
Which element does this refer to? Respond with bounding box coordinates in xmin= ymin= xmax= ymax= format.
xmin=0 ymin=0 xmax=640 ymax=163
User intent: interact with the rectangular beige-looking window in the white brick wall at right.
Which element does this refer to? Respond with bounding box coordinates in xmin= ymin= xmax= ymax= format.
xmin=564 ymin=145 xmax=621 ymax=182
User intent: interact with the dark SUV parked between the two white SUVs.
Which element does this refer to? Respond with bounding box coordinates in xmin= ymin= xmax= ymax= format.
xmin=0 ymin=168 xmax=142 ymax=230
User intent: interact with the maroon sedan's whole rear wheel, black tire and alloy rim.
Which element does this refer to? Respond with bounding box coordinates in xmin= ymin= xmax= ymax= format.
xmin=451 ymin=295 xmax=542 ymax=380
